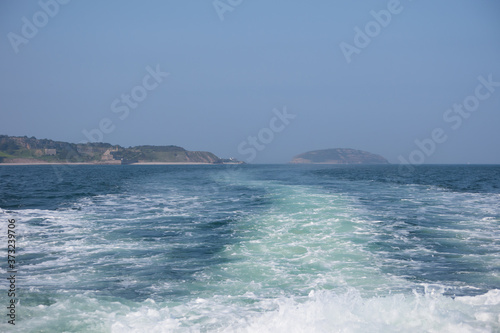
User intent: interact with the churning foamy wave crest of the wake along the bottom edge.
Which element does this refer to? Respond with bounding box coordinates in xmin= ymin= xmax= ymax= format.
xmin=0 ymin=286 xmax=500 ymax=333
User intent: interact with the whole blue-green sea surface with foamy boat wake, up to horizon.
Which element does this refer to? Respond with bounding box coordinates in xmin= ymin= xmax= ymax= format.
xmin=0 ymin=165 xmax=500 ymax=333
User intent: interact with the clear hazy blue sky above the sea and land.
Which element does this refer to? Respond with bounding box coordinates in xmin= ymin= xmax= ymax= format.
xmin=0 ymin=0 xmax=500 ymax=164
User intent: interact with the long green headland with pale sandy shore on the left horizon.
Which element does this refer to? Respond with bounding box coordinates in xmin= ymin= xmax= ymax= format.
xmin=0 ymin=135 xmax=244 ymax=164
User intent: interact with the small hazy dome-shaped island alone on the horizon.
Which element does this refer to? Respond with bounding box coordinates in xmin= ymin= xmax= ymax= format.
xmin=290 ymin=148 xmax=389 ymax=164
